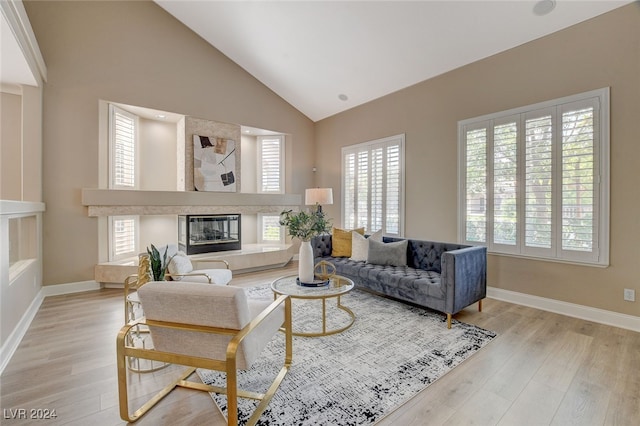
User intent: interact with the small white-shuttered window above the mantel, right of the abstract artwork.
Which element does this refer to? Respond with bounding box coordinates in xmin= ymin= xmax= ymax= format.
xmin=258 ymin=135 xmax=284 ymax=194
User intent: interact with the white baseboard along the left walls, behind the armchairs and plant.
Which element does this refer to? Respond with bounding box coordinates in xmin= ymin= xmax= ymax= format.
xmin=0 ymin=281 xmax=101 ymax=373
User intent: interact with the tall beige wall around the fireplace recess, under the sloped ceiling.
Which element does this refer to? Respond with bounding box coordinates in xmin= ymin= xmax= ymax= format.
xmin=25 ymin=1 xmax=313 ymax=285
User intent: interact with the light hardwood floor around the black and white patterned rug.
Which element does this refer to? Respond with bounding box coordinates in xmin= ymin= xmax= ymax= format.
xmin=0 ymin=263 xmax=640 ymax=426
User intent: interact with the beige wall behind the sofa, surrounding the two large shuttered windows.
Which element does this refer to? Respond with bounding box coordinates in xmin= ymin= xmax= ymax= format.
xmin=315 ymin=3 xmax=640 ymax=316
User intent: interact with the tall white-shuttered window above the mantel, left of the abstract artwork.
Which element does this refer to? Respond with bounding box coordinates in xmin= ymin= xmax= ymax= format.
xmin=109 ymin=105 xmax=138 ymax=189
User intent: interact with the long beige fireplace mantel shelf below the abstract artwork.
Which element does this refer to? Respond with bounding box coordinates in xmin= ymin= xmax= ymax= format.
xmin=82 ymin=188 xmax=302 ymax=217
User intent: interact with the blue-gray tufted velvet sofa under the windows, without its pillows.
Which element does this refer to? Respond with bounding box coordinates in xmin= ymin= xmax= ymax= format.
xmin=311 ymin=235 xmax=487 ymax=328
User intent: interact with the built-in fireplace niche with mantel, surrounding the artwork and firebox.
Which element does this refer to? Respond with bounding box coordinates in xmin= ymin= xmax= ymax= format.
xmin=97 ymin=101 xmax=288 ymax=253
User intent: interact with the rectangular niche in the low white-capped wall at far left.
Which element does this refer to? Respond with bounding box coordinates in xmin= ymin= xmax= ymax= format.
xmin=8 ymin=215 xmax=38 ymax=278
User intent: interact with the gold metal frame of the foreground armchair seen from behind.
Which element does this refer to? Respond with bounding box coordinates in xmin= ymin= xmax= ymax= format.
xmin=116 ymin=296 xmax=293 ymax=426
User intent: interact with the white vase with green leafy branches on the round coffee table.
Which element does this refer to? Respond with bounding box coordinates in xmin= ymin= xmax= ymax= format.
xmin=280 ymin=209 xmax=331 ymax=283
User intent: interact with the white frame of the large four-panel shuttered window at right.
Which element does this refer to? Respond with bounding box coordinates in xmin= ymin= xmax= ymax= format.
xmin=458 ymin=87 xmax=610 ymax=267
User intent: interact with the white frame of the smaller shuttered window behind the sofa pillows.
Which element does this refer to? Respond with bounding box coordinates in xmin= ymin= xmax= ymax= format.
xmin=340 ymin=133 xmax=406 ymax=237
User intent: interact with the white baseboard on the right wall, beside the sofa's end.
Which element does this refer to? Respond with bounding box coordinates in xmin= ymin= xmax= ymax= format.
xmin=487 ymin=287 xmax=640 ymax=332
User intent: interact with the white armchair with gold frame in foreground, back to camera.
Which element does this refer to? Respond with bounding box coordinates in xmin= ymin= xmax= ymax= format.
xmin=117 ymin=281 xmax=292 ymax=426
